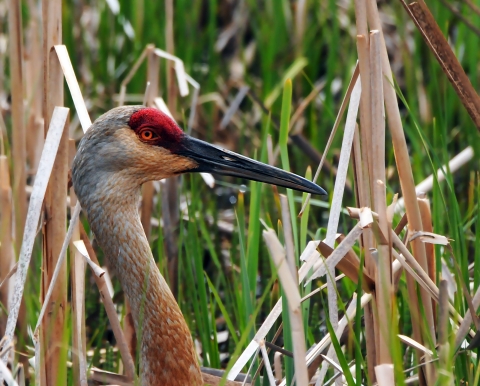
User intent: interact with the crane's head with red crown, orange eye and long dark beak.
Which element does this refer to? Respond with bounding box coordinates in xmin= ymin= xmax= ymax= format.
xmin=73 ymin=106 xmax=326 ymax=195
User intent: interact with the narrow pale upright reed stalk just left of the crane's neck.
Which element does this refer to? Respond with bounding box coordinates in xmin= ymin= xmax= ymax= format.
xmin=68 ymin=139 xmax=88 ymax=386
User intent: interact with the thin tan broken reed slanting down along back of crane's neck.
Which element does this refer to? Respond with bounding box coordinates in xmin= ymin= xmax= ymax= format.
xmin=79 ymin=223 xmax=135 ymax=381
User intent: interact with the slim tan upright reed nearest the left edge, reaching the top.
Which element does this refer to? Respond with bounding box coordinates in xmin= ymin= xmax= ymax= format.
xmin=8 ymin=0 xmax=27 ymax=253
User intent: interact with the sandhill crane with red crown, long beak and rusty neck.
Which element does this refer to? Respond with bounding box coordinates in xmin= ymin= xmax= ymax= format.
xmin=72 ymin=106 xmax=326 ymax=386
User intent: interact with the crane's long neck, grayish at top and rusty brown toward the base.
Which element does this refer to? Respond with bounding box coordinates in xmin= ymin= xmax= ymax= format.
xmin=75 ymin=175 xmax=203 ymax=386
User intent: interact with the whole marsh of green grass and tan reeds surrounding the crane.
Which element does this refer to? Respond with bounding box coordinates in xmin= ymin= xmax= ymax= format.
xmin=0 ymin=0 xmax=480 ymax=385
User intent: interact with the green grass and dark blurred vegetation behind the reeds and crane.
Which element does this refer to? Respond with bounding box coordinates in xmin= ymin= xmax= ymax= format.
xmin=0 ymin=0 xmax=480 ymax=385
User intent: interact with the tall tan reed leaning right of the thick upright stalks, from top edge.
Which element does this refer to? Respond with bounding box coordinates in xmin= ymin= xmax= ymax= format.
xmin=367 ymin=0 xmax=435 ymax=354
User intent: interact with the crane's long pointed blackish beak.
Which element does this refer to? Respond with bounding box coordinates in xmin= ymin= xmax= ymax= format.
xmin=176 ymin=135 xmax=327 ymax=195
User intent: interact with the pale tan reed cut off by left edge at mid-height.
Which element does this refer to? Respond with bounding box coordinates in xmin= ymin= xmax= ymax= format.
xmin=0 ymin=155 xmax=15 ymax=336
